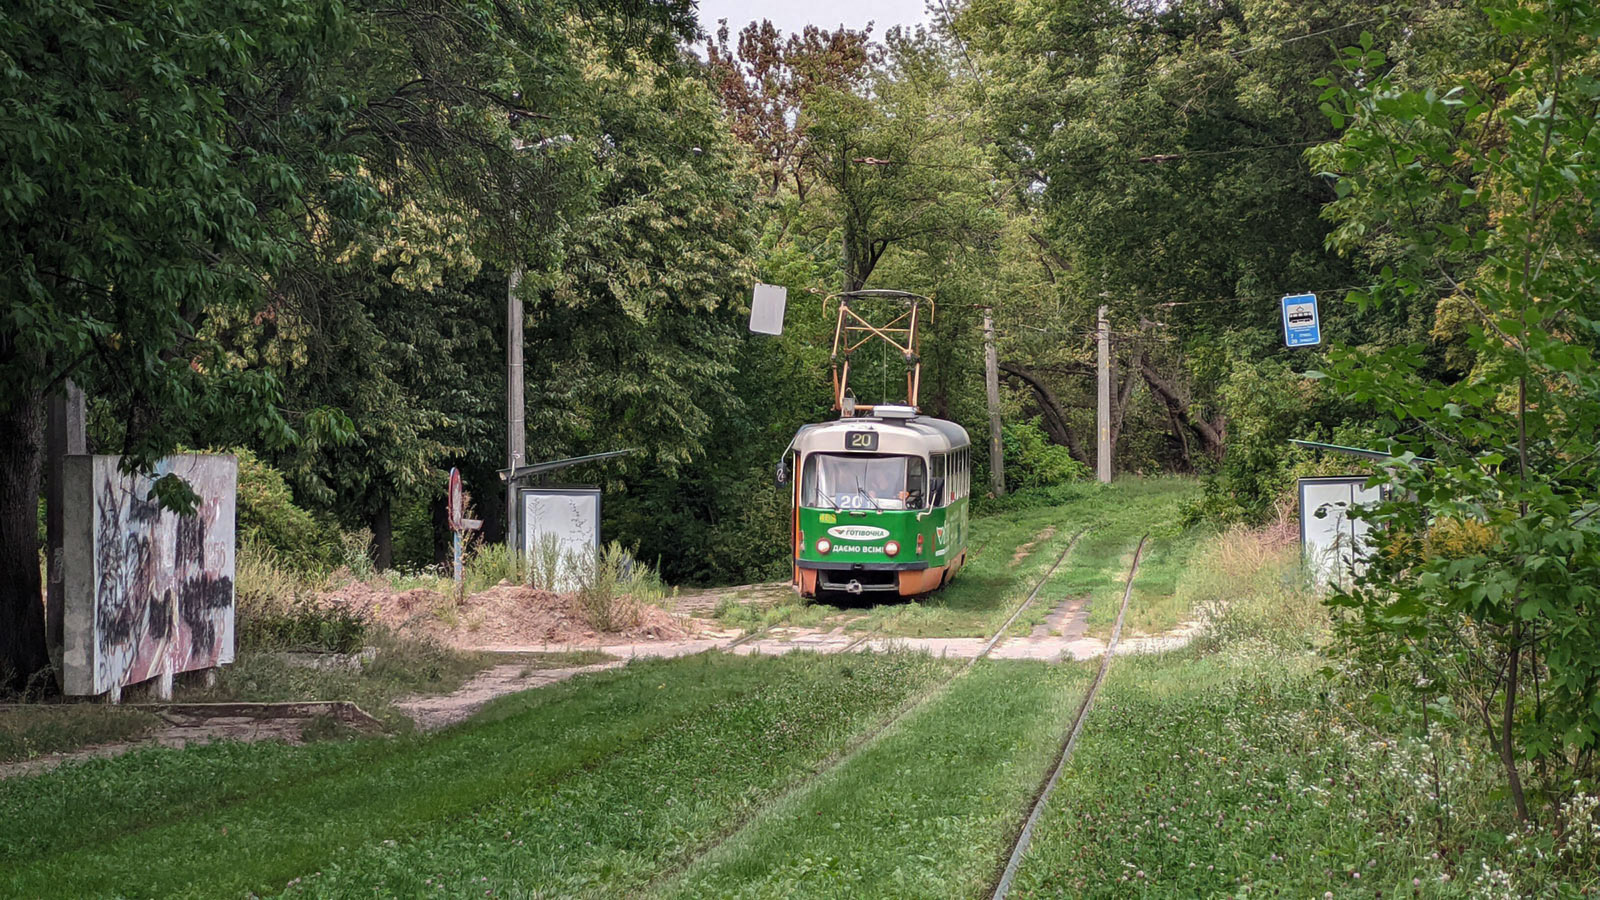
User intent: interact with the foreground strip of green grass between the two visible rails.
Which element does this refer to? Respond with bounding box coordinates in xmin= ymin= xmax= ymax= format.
xmin=666 ymin=661 xmax=1090 ymax=897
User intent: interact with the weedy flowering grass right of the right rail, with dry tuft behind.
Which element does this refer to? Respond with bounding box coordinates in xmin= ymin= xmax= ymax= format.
xmin=1013 ymin=533 xmax=1600 ymax=897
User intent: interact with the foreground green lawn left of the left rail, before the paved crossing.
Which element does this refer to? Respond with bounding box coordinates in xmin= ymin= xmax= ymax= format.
xmin=0 ymin=655 xmax=950 ymax=897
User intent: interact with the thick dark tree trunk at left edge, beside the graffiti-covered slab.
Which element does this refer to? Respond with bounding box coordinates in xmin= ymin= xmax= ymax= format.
xmin=0 ymin=389 xmax=50 ymax=690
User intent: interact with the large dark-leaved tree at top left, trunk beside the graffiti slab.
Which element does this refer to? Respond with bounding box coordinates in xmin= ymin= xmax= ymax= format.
xmin=0 ymin=0 xmax=693 ymax=684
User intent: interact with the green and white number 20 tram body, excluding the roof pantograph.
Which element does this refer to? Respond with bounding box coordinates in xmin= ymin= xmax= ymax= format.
xmin=786 ymin=404 xmax=973 ymax=597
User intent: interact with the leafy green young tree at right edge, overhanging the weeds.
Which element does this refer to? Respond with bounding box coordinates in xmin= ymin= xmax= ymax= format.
xmin=1317 ymin=0 xmax=1600 ymax=818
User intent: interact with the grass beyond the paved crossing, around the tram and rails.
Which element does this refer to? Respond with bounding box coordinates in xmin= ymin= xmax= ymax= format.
xmin=718 ymin=479 xmax=1198 ymax=637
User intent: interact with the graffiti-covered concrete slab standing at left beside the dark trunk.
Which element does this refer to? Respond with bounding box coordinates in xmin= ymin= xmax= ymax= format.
xmin=62 ymin=453 xmax=238 ymax=695
